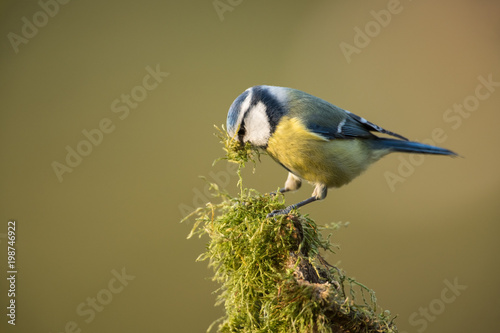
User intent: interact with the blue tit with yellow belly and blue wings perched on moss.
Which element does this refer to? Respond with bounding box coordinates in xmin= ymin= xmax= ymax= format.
xmin=227 ymin=85 xmax=456 ymax=216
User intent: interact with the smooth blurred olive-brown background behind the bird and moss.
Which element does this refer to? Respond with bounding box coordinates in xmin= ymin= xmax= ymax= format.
xmin=0 ymin=0 xmax=500 ymax=332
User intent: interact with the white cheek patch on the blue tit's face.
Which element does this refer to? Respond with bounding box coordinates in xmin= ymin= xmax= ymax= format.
xmin=243 ymin=102 xmax=271 ymax=146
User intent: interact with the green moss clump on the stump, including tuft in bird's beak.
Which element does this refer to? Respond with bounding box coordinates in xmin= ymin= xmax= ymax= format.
xmin=186 ymin=126 xmax=397 ymax=332
